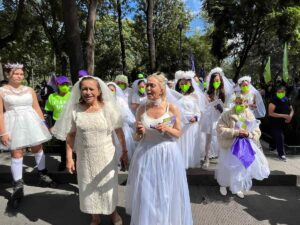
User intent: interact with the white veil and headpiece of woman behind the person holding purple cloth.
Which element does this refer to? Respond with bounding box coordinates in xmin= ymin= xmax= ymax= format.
xmin=235 ymin=76 xmax=266 ymax=118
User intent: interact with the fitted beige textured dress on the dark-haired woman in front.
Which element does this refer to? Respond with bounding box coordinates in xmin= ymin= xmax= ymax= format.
xmin=72 ymin=106 xmax=122 ymax=214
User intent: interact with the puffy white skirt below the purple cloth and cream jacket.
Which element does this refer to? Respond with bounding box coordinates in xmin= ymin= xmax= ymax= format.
xmin=215 ymin=140 xmax=270 ymax=194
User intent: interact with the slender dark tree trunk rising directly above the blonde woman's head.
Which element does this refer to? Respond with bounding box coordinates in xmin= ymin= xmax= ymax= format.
xmin=146 ymin=0 xmax=156 ymax=72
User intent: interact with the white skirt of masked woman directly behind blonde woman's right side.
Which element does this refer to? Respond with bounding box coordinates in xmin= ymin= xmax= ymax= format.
xmin=177 ymin=122 xmax=205 ymax=169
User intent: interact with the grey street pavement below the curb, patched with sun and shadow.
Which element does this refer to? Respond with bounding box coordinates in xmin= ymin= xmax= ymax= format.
xmin=0 ymin=184 xmax=300 ymax=225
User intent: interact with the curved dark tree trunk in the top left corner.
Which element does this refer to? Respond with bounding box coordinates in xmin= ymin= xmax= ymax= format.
xmin=0 ymin=0 xmax=25 ymax=49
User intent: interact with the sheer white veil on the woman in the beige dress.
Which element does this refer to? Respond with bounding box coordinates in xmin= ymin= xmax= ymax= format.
xmin=52 ymin=76 xmax=122 ymax=140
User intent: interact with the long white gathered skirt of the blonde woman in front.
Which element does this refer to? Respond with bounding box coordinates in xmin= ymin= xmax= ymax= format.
xmin=126 ymin=141 xmax=193 ymax=225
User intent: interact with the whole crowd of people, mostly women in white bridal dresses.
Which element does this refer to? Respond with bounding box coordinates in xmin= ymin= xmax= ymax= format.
xmin=0 ymin=64 xmax=294 ymax=225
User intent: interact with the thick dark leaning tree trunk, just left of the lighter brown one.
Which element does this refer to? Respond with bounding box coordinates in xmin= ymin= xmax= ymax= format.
xmin=62 ymin=0 xmax=83 ymax=83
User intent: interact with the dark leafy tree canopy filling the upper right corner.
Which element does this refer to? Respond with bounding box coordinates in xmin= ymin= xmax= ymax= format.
xmin=204 ymin=0 xmax=300 ymax=80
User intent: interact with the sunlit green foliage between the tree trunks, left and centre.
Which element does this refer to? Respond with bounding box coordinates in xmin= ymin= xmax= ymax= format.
xmin=0 ymin=0 xmax=216 ymax=82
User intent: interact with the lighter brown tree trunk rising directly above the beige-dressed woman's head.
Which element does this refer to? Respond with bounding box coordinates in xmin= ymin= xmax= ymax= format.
xmin=86 ymin=0 xmax=98 ymax=75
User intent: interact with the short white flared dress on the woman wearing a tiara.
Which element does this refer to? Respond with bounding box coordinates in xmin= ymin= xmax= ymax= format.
xmin=0 ymin=86 xmax=51 ymax=150
